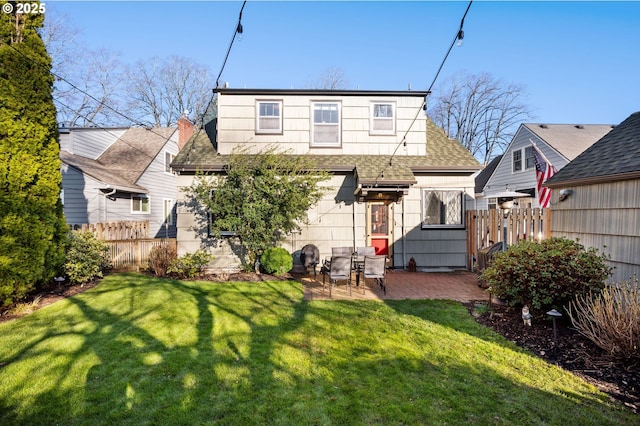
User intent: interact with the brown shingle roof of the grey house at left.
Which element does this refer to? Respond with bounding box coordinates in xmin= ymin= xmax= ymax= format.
xmin=60 ymin=127 xmax=177 ymax=193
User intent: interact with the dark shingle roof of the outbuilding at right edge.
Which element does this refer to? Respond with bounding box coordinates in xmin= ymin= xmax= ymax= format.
xmin=545 ymin=112 xmax=640 ymax=188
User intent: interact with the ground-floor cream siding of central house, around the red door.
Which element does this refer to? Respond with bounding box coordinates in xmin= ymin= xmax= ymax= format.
xmin=177 ymin=171 xmax=473 ymax=269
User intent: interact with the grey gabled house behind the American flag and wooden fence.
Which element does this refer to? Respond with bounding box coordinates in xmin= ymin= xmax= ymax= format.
xmin=476 ymin=123 xmax=613 ymax=210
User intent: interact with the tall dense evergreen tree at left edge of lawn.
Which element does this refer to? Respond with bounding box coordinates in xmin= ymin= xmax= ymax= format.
xmin=0 ymin=2 xmax=66 ymax=305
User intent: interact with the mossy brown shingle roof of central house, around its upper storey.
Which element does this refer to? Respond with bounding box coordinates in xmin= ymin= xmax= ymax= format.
xmin=171 ymin=116 xmax=480 ymax=184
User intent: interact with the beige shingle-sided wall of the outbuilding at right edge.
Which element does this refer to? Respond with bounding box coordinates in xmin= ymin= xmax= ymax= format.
xmin=551 ymin=180 xmax=640 ymax=282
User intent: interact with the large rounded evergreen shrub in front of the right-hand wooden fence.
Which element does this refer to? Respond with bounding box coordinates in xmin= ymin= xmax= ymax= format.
xmin=481 ymin=237 xmax=611 ymax=310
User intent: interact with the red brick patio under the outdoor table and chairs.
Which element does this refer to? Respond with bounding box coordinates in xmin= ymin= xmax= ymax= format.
xmin=302 ymin=270 xmax=489 ymax=303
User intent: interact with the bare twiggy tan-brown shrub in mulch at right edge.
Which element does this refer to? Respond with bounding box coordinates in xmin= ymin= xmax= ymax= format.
xmin=569 ymin=277 xmax=640 ymax=359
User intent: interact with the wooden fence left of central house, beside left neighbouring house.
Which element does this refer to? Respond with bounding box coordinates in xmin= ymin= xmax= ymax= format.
xmin=106 ymin=238 xmax=177 ymax=271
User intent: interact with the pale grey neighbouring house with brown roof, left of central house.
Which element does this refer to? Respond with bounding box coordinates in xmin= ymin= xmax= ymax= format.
xmin=60 ymin=118 xmax=191 ymax=238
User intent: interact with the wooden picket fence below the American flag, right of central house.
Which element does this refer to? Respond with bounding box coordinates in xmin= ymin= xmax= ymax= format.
xmin=466 ymin=208 xmax=551 ymax=270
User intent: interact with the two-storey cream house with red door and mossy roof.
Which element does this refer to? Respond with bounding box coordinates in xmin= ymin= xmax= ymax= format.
xmin=172 ymin=88 xmax=480 ymax=269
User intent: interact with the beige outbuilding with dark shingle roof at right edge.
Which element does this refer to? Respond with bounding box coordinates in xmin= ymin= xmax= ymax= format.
xmin=545 ymin=112 xmax=640 ymax=282
